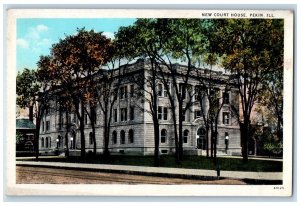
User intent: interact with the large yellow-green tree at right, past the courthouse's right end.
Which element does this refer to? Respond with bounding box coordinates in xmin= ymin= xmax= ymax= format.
xmin=211 ymin=19 xmax=283 ymax=161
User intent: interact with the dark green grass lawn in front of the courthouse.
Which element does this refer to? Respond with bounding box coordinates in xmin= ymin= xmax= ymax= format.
xmin=22 ymin=155 xmax=282 ymax=172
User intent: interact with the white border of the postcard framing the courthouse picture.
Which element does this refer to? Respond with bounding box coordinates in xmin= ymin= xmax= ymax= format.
xmin=4 ymin=9 xmax=294 ymax=196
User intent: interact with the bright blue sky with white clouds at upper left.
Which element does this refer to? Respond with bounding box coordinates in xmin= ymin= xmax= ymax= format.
xmin=16 ymin=18 xmax=136 ymax=71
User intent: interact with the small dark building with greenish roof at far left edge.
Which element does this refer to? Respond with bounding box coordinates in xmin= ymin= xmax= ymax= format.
xmin=16 ymin=118 xmax=36 ymax=153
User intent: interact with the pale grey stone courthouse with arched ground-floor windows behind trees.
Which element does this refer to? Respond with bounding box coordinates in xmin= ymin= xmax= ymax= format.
xmin=39 ymin=60 xmax=241 ymax=155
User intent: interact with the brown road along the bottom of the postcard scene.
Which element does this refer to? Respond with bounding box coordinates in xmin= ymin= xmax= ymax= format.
xmin=16 ymin=166 xmax=246 ymax=185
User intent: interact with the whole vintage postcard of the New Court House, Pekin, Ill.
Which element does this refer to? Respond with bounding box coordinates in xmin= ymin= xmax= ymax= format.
xmin=5 ymin=9 xmax=294 ymax=196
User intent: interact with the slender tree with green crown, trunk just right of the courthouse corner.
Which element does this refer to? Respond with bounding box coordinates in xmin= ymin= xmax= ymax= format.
xmin=116 ymin=19 xmax=160 ymax=166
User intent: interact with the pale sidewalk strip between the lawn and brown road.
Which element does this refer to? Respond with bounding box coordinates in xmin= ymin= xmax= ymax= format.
xmin=16 ymin=160 xmax=282 ymax=181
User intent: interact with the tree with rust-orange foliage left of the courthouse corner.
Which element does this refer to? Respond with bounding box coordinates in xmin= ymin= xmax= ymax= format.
xmin=49 ymin=28 xmax=112 ymax=158
